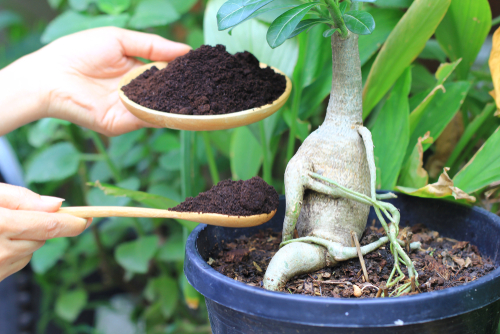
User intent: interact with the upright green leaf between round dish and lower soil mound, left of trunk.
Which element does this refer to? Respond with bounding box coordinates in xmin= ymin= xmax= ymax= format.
xmin=230 ymin=126 xmax=262 ymax=180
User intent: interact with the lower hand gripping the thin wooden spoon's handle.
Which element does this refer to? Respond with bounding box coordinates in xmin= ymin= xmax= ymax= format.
xmin=0 ymin=183 xmax=91 ymax=281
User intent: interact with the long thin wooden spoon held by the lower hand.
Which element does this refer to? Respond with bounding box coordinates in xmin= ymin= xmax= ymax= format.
xmin=57 ymin=206 xmax=276 ymax=227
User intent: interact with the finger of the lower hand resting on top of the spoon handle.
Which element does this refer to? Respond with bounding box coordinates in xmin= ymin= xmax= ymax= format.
xmin=0 ymin=183 xmax=64 ymax=212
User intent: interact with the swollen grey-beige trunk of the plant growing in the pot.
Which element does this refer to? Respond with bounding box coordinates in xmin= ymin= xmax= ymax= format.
xmin=264 ymin=34 xmax=375 ymax=290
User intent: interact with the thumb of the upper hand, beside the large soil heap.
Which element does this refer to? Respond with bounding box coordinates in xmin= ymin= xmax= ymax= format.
xmin=115 ymin=28 xmax=191 ymax=61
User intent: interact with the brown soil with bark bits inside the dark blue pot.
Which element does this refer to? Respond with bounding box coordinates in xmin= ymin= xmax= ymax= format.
xmin=208 ymin=224 xmax=495 ymax=298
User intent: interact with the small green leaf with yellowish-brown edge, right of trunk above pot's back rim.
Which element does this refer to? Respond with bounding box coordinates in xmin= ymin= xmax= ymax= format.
xmin=398 ymin=132 xmax=434 ymax=189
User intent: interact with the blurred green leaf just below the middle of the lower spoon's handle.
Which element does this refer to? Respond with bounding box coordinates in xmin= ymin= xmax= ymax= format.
xmin=115 ymin=235 xmax=158 ymax=274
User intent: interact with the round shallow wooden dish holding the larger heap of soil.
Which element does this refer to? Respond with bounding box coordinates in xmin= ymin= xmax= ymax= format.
xmin=118 ymin=62 xmax=292 ymax=131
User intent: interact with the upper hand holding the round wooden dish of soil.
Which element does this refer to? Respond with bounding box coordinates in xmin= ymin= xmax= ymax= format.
xmin=0 ymin=27 xmax=190 ymax=136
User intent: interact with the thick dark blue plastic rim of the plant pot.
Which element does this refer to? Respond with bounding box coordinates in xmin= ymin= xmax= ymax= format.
xmin=184 ymin=194 xmax=500 ymax=328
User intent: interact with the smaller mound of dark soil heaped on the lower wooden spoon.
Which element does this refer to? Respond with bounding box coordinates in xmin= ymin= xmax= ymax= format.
xmin=170 ymin=176 xmax=279 ymax=216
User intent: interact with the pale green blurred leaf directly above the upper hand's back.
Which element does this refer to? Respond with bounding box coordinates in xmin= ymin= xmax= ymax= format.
xmin=41 ymin=10 xmax=129 ymax=44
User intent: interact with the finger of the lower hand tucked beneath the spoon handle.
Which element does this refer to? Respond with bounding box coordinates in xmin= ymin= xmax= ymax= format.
xmin=0 ymin=209 xmax=90 ymax=240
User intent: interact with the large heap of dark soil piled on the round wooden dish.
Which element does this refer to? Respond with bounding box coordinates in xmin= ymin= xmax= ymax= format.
xmin=122 ymin=45 xmax=286 ymax=115
